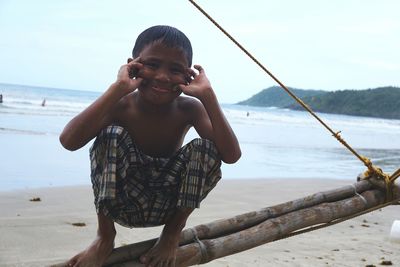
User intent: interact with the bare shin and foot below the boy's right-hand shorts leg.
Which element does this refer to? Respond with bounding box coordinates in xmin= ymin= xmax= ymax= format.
xmin=140 ymin=208 xmax=193 ymax=267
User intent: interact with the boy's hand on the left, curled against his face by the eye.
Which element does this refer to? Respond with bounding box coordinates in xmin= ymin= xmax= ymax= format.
xmin=116 ymin=57 xmax=143 ymax=94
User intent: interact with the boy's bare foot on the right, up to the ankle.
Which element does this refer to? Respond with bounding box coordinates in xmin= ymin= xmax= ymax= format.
xmin=140 ymin=228 xmax=181 ymax=267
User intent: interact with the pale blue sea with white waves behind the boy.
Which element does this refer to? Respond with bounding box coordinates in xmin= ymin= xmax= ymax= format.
xmin=0 ymin=84 xmax=400 ymax=190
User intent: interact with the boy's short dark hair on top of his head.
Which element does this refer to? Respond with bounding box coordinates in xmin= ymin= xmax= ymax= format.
xmin=132 ymin=25 xmax=193 ymax=66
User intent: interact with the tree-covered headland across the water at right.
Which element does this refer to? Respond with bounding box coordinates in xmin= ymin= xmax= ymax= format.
xmin=238 ymin=86 xmax=400 ymax=119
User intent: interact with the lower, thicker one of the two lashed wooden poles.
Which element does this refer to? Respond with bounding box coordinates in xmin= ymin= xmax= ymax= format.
xmin=104 ymin=190 xmax=385 ymax=267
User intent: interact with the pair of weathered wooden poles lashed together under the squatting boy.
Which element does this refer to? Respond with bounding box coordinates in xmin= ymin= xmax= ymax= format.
xmin=52 ymin=178 xmax=400 ymax=267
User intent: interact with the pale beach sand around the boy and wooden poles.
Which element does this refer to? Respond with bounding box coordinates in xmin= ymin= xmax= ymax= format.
xmin=0 ymin=179 xmax=400 ymax=267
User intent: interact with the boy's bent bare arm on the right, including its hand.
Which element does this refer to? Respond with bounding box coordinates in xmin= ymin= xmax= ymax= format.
xmin=181 ymin=65 xmax=241 ymax=163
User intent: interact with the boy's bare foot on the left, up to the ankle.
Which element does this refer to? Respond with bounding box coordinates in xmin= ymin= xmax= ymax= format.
xmin=67 ymin=235 xmax=115 ymax=267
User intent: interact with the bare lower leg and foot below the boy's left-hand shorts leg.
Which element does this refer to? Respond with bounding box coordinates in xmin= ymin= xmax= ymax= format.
xmin=67 ymin=213 xmax=116 ymax=267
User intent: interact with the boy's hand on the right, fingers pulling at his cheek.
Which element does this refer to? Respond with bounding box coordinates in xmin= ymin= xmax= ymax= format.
xmin=180 ymin=65 xmax=212 ymax=100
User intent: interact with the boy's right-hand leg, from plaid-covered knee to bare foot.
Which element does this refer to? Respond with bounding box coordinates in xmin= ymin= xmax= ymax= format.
xmin=140 ymin=139 xmax=221 ymax=266
